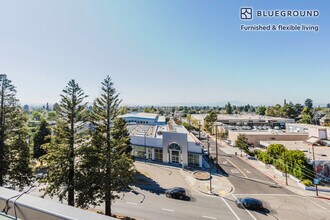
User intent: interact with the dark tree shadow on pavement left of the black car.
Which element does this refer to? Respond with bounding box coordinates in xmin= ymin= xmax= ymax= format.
xmin=134 ymin=172 xmax=166 ymax=195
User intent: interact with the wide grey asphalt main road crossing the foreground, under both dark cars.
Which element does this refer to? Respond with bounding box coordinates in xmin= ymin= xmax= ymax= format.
xmin=21 ymin=158 xmax=330 ymax=220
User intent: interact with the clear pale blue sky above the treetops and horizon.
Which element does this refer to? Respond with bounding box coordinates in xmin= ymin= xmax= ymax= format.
xmin=0 ymin=0 xmax=330 ymax=105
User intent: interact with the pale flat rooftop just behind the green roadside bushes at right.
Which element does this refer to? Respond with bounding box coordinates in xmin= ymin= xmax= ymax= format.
xmin=260 ymin=141 xmax=330 ymax=161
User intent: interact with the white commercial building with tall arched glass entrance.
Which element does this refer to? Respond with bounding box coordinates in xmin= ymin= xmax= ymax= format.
xmin=128 ymin=124 xmax=202 ymax=167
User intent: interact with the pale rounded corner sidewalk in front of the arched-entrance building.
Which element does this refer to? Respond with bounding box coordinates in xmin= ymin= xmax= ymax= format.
xmin=180 ymin=170 xmax=234 ymax=196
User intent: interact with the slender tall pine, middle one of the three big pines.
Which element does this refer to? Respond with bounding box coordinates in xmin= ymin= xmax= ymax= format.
xmin=42 ymin=80 xmax=88 ymax=206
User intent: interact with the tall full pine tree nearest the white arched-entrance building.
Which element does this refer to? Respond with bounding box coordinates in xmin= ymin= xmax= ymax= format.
xmin=77 ymin=76 xmax=134 ymax=216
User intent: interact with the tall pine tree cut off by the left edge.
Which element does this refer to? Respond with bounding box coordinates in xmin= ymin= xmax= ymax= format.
xmin=0 ymin=75 xmax=32 ymax=188
